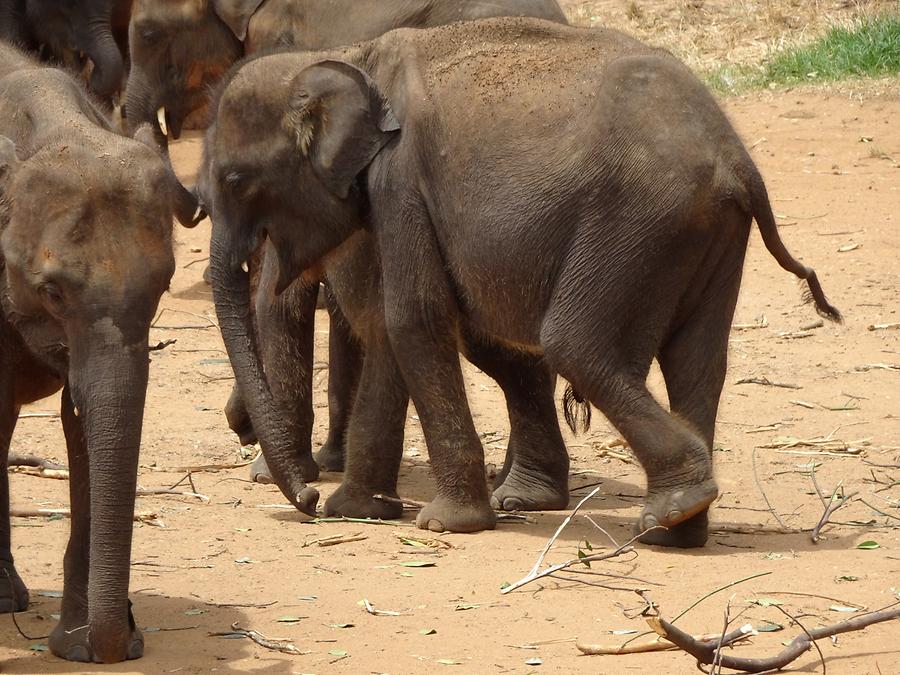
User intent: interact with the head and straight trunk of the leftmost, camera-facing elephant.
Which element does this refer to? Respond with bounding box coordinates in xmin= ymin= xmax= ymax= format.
xmin=0 ymin=136 xmax=175 ymax=662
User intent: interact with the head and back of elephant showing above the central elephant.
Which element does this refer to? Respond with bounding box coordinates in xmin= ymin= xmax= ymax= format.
xmin=125 ymin=0 xmax=566 ymax=142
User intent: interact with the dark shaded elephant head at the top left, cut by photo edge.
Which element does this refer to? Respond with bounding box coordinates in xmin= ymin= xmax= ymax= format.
xmin=26 ymin=0 xmax=130 ymax=99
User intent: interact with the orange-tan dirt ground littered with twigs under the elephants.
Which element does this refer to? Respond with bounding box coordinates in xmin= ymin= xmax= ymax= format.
xmin=0 ymin=2 xmax=900 ymax=674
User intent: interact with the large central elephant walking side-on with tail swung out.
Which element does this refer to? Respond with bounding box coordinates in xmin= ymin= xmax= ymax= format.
xmin=203 ymin=19 xmax=840 ymax=546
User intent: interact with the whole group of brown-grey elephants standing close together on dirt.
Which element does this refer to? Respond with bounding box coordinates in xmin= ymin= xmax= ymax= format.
xmin=0 ymin=0 xmax=840 ymax=662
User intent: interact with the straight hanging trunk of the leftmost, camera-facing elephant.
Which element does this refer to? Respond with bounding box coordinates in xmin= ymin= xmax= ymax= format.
xmin=69 ymin=330 xmax=149 ymax=663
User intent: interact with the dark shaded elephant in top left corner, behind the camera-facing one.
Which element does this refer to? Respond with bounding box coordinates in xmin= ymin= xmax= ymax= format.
xmin=0 ymin=0 xmax=132 ymax=100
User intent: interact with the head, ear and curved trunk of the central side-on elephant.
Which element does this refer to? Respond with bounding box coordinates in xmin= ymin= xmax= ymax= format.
xmin=209 ymin=55 xmax=399 ymax=514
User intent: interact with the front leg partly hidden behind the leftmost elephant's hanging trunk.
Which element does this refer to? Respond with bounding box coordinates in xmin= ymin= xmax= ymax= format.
xmin=48 ymin=384 xmax=144 ymax=663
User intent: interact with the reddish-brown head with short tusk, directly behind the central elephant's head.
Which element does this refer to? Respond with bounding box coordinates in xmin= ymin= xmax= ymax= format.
xmin=125 ymin=0 xmax=262 ymax=145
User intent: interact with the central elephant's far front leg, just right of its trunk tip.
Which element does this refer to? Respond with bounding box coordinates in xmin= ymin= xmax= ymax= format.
xmin=325 ymin=336 xmax=409 ymax=519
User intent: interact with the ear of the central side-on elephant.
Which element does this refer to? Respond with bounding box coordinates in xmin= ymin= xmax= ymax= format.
xmin=284 ymin=61 xmax=400 ymax=199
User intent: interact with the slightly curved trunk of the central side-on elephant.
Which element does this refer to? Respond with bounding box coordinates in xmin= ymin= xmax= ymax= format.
xmin=210 ymin=221 xmax=319 ymax=515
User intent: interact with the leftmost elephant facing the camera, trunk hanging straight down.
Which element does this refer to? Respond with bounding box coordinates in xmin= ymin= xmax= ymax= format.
xmin=0 ymin=47 xmax=177 ymax=662
